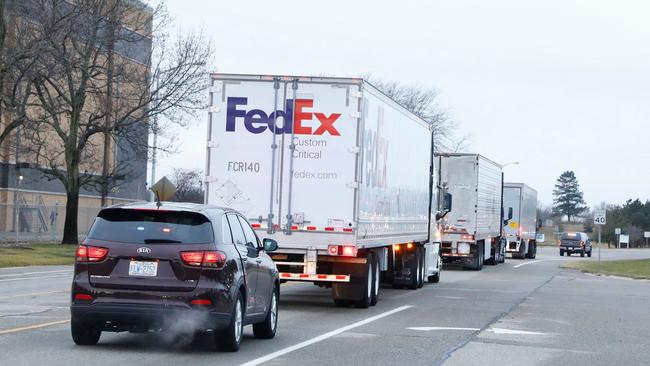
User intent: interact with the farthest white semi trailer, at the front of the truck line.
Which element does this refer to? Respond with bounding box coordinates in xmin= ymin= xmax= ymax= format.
xmin=503 ymin=183 xmax=537 ymax=259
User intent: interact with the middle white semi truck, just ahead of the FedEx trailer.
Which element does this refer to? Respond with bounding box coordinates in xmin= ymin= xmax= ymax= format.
xmin=436 ymin=153 xmax=505 ymax=270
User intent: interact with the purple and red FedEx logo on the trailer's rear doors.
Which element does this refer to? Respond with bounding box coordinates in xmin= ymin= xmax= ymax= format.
xmin=226 ymin=97 xmax=341 ymax=136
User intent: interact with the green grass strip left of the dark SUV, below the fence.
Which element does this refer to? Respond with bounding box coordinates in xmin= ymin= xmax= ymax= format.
xmin=0 ymin=244 xmax=77 ymax=268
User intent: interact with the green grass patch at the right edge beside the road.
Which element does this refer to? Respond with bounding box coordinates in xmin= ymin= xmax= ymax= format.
xmin=562 ymin=259 xmax=650 ymax=279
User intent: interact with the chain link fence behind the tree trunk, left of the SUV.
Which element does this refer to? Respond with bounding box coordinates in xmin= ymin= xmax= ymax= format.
xmin=0 ymin=202 xmax=100 ymax=242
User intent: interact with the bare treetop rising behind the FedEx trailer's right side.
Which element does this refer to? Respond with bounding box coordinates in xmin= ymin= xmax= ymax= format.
xmin=366 ymin=76 xmax=469 ymax=152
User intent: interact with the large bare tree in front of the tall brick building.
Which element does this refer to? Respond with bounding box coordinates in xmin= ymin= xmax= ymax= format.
xmin=20 ymin=0 xmax=212 ymax=243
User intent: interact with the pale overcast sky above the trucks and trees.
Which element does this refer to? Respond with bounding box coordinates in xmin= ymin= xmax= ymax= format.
xmin=159 ymin=0 xmax=650 ymax=206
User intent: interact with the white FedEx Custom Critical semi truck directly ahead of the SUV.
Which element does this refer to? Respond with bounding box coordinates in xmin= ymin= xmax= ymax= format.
xmin=205 ymin=74 xmax=451 ymax=307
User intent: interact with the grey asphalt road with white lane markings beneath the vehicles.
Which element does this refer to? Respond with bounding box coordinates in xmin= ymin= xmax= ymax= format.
xmin=0 ymin=248 xmax=650 ymax=366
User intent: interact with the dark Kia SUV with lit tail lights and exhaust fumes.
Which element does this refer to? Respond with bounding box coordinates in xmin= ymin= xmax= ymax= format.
xmin=70 ymin=203 xmax=280 ymax=351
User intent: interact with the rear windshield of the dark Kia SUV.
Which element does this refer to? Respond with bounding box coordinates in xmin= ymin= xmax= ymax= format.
xmin=88 ymin=209 xmax=214 ymax=244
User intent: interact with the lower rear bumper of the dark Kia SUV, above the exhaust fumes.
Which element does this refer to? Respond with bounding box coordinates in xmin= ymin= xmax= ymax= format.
xmin=70 ymin=303 xmax=232 ymax=332
